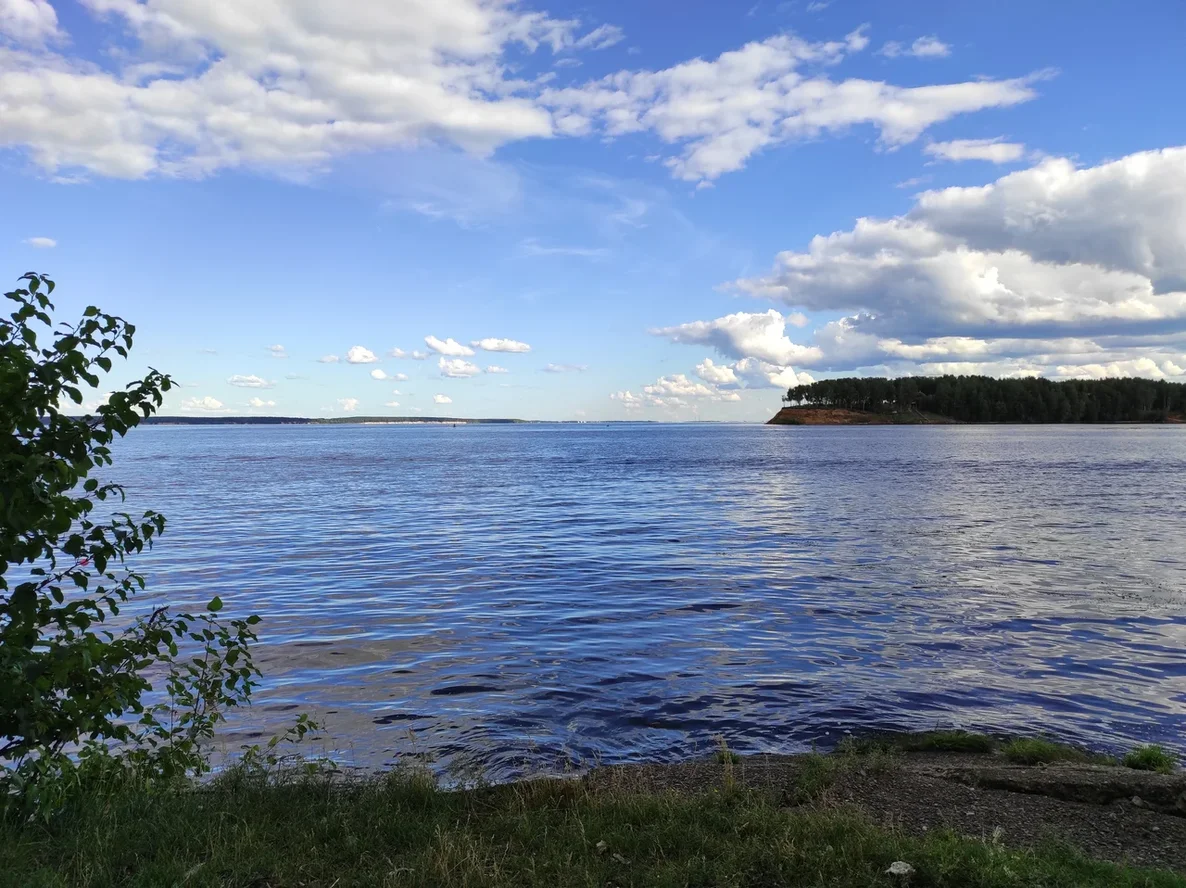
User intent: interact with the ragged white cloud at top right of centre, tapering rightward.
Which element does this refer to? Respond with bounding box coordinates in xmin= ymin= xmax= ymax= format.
xmin=541 ymin=30 xmax=1035 ymax=181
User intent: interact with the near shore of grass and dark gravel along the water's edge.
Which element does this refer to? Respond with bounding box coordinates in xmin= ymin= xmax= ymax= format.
xmin=0 ymin=732 xmax=1186 ymax=888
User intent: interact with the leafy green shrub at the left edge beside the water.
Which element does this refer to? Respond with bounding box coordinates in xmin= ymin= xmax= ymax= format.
xmin=0 ymin=274 xmax=270 ymax=814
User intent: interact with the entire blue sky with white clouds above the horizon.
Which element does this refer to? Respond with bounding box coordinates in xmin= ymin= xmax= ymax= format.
xmin=0 ymin=0 xmax=1186 ymax=421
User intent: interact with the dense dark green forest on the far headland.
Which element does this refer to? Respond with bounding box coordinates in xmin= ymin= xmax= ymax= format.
xmin=783 ymin=376 xmax=1186 ymax=422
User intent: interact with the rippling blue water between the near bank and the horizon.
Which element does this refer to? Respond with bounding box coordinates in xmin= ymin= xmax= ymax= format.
xmin=104 ymin=424 xmax=1186 ymax=775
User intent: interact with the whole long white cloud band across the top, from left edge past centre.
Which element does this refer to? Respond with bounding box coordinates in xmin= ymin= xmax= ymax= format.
xmin=0 ymin=12 xmax=1034 ymax=181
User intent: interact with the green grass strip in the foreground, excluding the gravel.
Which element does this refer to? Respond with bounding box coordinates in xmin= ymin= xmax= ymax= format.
xmin=0 ymin=756 xmax=1186 ymax=888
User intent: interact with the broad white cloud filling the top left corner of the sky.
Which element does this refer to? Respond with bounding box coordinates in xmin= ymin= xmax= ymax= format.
xmin=0 ymin=0 xmax=574 ymax=178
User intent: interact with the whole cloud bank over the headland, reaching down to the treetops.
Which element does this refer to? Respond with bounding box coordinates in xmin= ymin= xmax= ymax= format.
xmin=711 ymin=147 xmax=1186 ymax=376
